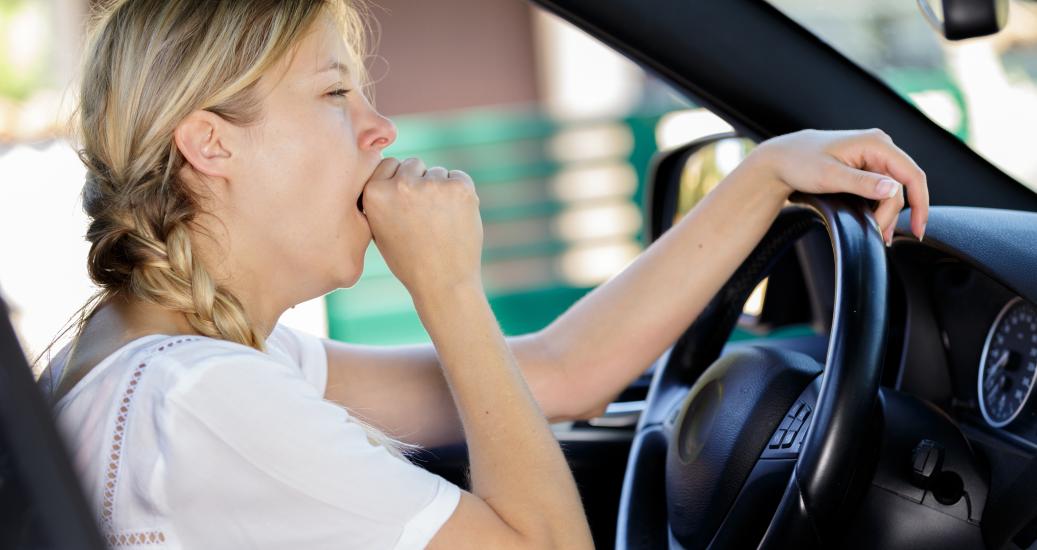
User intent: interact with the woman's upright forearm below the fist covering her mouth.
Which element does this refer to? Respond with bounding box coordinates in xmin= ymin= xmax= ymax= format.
xmin=415 ymin=280 xmax=591 ymax=548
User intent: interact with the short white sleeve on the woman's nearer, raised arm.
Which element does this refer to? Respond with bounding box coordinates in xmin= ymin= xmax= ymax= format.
xmin=159 ymin=352 xmax=460 ymax=549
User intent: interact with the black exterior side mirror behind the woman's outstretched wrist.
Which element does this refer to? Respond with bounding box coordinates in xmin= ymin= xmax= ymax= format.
xmin=645 ymin=132 xmax=755 ymax=243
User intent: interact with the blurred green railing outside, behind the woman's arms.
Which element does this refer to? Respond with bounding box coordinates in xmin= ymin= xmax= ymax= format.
xmin=327 ymin=104 xmax=662 ymax=345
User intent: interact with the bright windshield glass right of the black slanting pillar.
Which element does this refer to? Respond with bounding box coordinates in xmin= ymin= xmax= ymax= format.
xmin=769 ymin=0 xmax=1037 ymax=190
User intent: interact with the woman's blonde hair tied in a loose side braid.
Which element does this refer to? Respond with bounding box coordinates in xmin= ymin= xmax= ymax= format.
xmin=50 ymin=0 xmax=407 ymax=455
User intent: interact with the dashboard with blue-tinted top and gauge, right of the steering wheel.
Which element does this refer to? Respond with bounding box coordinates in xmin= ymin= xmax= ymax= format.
xmin=884 ymin=207 xmax=1037 ymax=492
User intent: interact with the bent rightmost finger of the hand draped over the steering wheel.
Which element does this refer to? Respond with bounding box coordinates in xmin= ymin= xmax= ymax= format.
xmin=862 ymin=132 xmax=929 ymax=239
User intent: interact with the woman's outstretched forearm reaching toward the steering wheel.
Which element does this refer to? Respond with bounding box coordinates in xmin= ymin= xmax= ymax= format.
xmin=540 ymin=151 xmax=788 ymax=411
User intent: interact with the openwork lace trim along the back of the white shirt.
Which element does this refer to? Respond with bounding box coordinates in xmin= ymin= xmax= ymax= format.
xmin=101 ymin=338 xmax=197 ymax=546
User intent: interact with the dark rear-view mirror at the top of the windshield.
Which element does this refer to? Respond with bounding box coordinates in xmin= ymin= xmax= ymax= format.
xmin=918 ymin=0 xmax=1008 ymax=40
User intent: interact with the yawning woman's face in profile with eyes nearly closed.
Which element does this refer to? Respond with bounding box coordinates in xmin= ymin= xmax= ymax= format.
xmin=228 ymin=19 xmax=396 ymax=297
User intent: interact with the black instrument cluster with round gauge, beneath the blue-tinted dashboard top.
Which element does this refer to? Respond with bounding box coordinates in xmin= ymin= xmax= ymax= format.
xmin=894 ymin=247 xmax=1037 ymax=442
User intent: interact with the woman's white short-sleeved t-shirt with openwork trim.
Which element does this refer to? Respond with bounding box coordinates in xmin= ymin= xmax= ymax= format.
xmin=40 ymin=325 xmax=460 ymax=549
